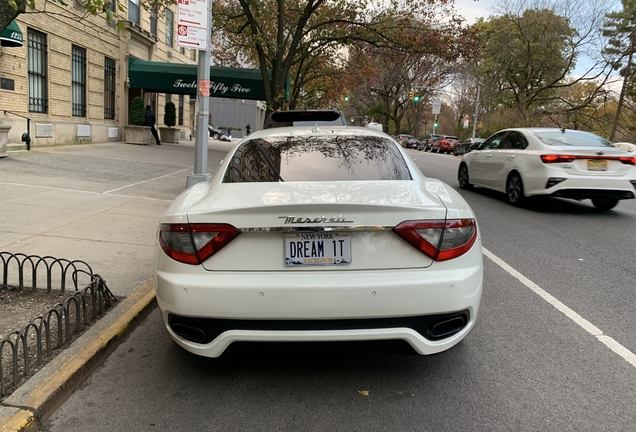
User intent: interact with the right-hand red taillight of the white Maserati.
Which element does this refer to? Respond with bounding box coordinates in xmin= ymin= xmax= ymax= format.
xmin=393 ymin=219 xmax=477 ymax=261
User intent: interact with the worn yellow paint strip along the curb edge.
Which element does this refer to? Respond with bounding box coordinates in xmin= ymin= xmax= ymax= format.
xmin=14 ymin=277 xmax=155 ymax=415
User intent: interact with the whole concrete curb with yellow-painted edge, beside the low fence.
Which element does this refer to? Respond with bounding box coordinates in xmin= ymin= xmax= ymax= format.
xmin=0 ymin=277 xmax=157 ymax=432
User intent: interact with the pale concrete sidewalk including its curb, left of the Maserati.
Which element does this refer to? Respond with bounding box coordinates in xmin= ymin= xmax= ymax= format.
xmin=0 ymin=139 xmax=239 ymax=432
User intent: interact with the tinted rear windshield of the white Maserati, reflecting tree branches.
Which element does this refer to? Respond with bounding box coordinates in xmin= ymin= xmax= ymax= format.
xmin=223 ymin=136 xmax=411 ymax=183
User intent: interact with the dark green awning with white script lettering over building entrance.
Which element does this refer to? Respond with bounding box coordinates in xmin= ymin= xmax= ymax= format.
xmin=128 ymin=58 xmax=290 ymax=100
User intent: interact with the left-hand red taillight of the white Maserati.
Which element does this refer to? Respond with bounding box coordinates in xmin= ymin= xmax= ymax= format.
xmin=159 ymin=224 xmax=240 ymax=265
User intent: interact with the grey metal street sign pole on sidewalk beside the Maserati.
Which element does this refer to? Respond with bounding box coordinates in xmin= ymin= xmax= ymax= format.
xmin=186 ymin=0 xmax=212 ymax=188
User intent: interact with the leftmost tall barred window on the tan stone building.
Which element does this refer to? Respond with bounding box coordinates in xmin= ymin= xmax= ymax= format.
xmin=27 ymin=29 xmax=49 ymax=114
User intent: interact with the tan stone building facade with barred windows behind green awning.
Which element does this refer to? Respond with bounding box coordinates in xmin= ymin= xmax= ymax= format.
xmin=0 ymin=0 xmax=199 ymax=147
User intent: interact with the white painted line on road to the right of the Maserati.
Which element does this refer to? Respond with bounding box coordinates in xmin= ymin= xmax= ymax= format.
xmin=482 ymin=248 xmax=636 ymax=367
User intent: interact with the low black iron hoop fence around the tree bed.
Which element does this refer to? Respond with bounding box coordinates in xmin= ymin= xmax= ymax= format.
xmin=0 ymin=252 xmax=117 ymax=398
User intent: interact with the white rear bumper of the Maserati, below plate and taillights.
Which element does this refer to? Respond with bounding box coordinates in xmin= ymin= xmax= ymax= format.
xmin=155 ymin=242 xmax=483 ymax=357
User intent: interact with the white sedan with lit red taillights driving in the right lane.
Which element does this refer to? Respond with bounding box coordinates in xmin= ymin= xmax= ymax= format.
xmin=457 ymin=128 xmax=636 ymax=210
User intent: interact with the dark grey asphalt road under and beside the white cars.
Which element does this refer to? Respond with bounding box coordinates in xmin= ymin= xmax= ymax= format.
xmin=46 ymin=147 xmax=636 ymax=432
